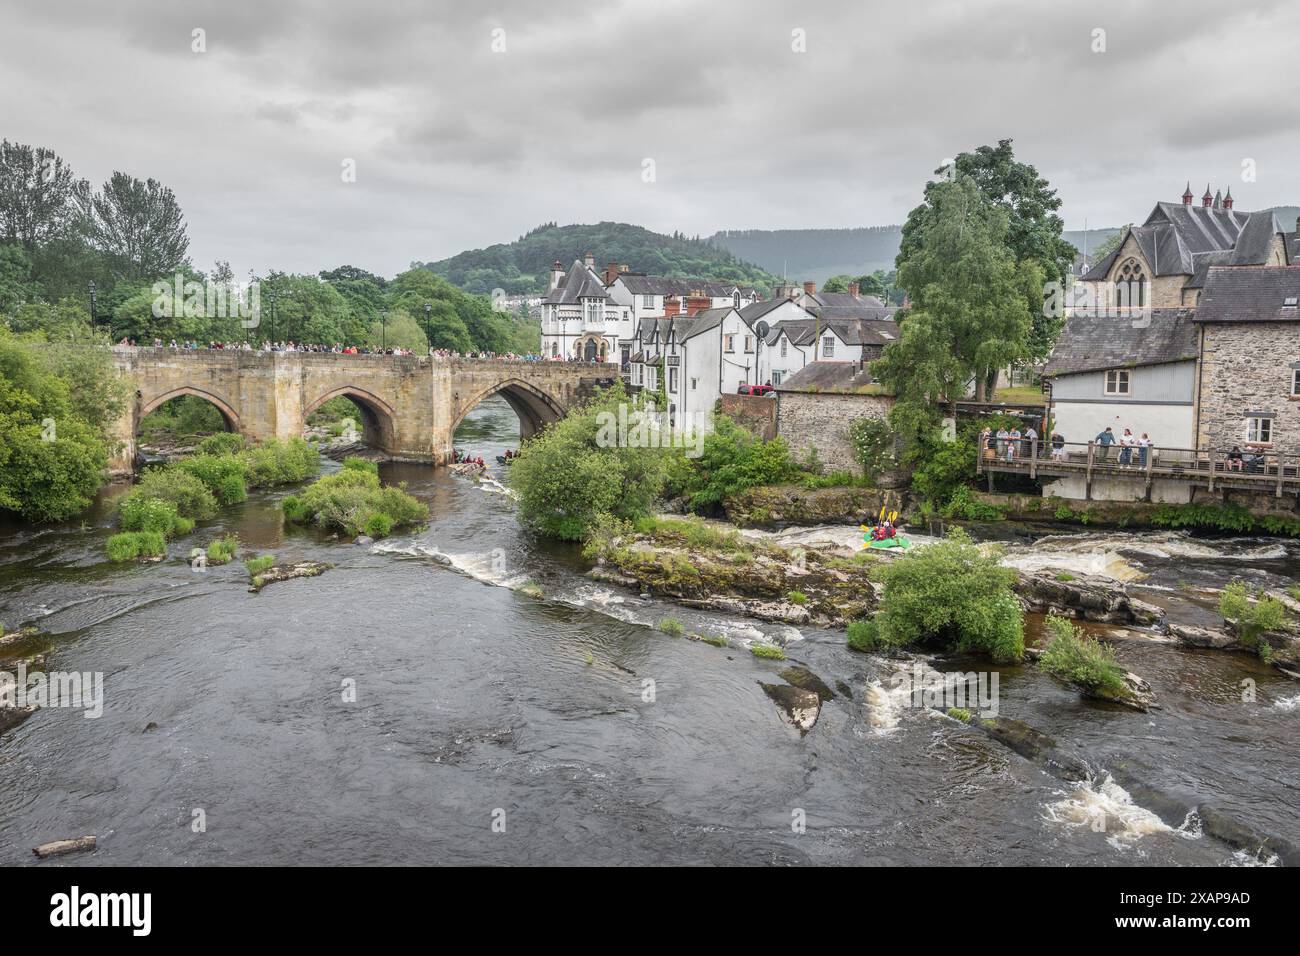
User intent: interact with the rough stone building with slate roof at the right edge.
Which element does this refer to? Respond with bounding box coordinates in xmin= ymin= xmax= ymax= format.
xmin=1193 ymin=265 xmax=1300 ymax=457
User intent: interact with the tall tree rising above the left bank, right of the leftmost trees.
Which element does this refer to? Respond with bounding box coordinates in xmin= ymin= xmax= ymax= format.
xmin=88 ymin=173 xmax=190 ymax=280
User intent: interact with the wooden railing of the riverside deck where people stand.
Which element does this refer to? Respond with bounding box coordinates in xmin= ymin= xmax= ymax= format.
xmin=975 ymin=436 xmax=1300 ymax=497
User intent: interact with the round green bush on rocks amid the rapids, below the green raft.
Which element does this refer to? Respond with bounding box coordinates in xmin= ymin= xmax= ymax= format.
xmin=874 ymin=528 xmax=1024 ymax=661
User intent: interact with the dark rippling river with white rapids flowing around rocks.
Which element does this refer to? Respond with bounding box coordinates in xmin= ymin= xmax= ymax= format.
xmin=0 ymin=399 xmax=1300 ymax=866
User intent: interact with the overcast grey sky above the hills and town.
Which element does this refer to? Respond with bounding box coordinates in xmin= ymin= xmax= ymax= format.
xmin=0 ymin=0 xmax=1300 ymax=274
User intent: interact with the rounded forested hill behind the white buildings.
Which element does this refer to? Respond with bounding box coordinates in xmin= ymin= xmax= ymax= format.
xmin=412 ymin=222 xmax=775 ymax=294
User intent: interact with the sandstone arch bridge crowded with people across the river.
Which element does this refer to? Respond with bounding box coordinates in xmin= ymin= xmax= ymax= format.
xmin=113 ymin=347 xmax=616 ymax=473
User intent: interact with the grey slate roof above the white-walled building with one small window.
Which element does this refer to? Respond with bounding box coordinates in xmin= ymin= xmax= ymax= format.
xmin=1043 ymin=308 xmax=1204 ymax=376
